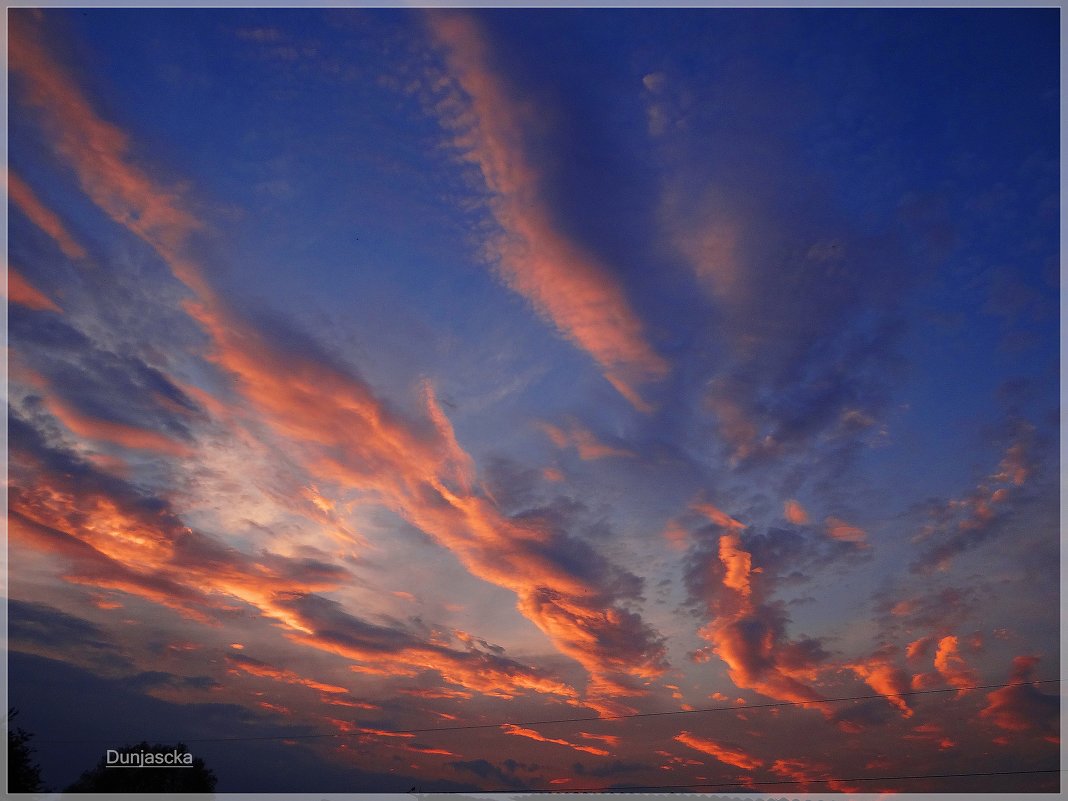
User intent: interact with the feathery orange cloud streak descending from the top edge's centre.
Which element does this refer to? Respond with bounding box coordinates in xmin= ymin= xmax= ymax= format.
xmin=427 ymin=13 xmax=669 ymax=410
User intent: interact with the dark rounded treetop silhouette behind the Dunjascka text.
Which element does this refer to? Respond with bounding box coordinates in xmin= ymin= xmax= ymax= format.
xmin=66 ymin=742 xmax=217 ymax=794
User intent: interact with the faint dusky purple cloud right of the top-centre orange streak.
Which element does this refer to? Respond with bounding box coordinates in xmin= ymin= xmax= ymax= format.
xmin=643 ymin=51 xmax=925 ymax=472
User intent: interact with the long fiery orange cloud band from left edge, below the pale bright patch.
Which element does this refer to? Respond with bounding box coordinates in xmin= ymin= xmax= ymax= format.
xmin=11 ymin=419 xmax=589 ymax=698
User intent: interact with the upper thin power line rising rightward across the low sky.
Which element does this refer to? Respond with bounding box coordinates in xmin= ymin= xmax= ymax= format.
xmin=36 ymin=678 xmax=1061 ymax=751
